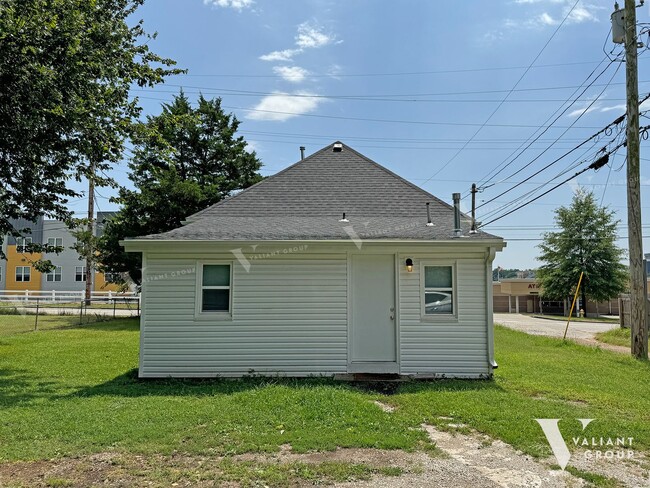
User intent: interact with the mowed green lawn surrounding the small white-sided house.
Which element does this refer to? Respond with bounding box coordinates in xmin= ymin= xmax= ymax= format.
xmin=0 ymin=316 xmax=650 ymax=469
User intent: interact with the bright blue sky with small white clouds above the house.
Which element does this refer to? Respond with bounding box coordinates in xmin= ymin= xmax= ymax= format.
xmin=73 ymin=0 xmax=650 ymax=268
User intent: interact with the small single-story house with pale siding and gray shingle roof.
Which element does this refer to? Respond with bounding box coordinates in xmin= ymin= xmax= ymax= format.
xmin=123 ymin=142 xmax=505 ymax=378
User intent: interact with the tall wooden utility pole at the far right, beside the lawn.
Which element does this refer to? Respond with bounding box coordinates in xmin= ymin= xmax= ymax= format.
xmin=624 ymin=0 xmax=648 ymax=359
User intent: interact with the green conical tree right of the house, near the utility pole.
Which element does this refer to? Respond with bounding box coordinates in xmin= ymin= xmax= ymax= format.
xmin=537 ymin=189 xmax=629 ymax=306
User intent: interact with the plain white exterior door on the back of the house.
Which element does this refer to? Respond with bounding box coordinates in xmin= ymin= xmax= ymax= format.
xmin=350 ymin=254 xmax=398 ymax=373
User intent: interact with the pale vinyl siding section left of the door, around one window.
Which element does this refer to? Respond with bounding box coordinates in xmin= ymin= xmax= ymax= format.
xmin=140 ymin=253 xmax=347 ymax=377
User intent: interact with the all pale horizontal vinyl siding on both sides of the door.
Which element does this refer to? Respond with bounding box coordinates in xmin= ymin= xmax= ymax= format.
xmin=140 ymin=243 xmax=490 ymax=377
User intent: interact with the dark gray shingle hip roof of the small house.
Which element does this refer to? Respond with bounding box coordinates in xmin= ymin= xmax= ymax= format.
xmin=139 ymin=143 xmax=495 ymax=241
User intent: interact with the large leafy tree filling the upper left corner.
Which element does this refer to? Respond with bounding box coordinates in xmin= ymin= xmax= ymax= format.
xmin=0 ymin=0 xmax=179 ymax=252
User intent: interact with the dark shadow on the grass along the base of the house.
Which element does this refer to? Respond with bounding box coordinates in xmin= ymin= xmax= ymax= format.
xmin=67 ymin=368 xmax=502 ymax=398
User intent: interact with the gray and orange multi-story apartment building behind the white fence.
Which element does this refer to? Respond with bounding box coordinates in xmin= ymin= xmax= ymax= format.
xmin=0 ymin=212 xmax=119 ymax=291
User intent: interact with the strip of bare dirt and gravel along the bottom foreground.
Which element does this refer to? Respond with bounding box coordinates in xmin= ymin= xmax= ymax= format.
xmin=0 ymin=432 xmax=650 ymax=488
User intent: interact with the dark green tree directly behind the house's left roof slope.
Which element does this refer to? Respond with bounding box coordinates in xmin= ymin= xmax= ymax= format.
xmin=99 ymin=92 xmax=262 ymax=283
